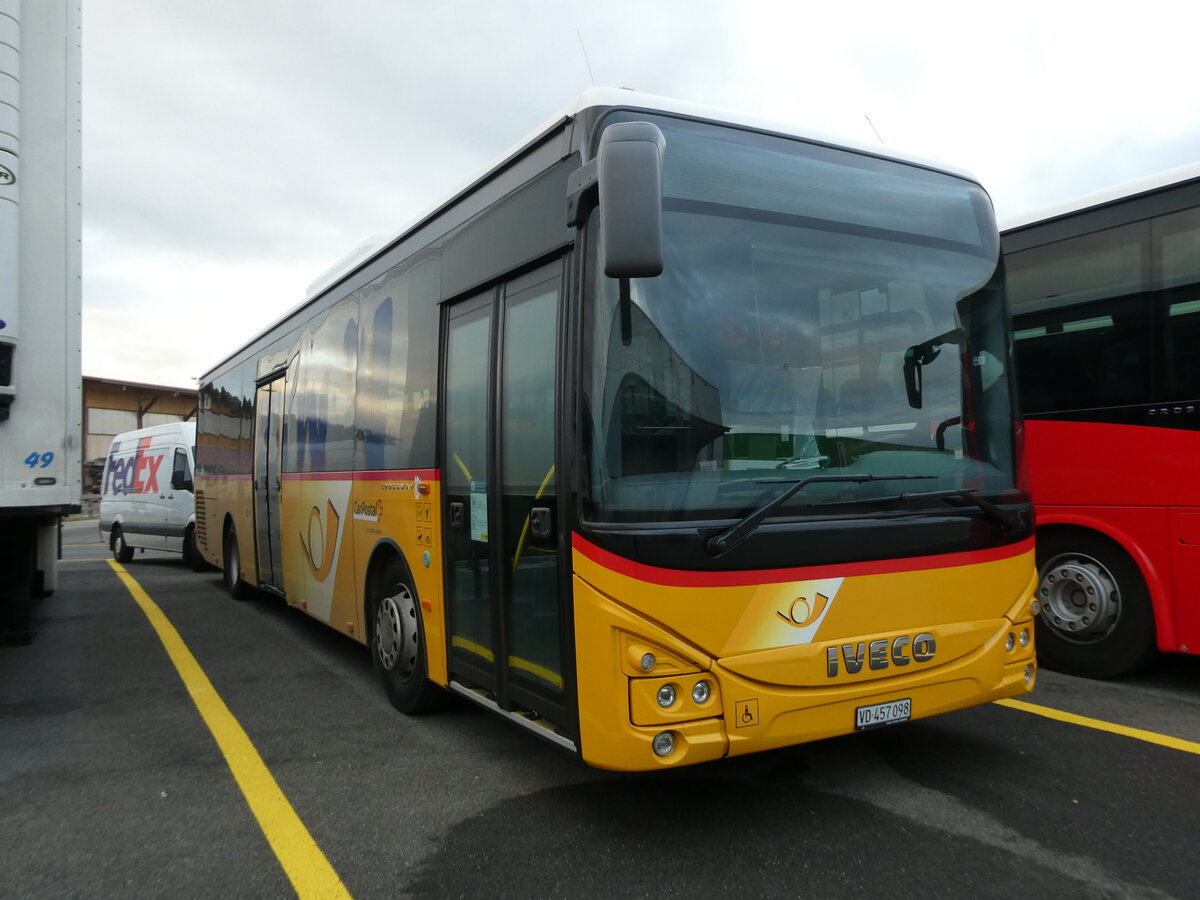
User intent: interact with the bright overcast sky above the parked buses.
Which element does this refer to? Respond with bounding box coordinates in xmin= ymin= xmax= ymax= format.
xmin=83 ymin=0 xmax=1200 ymax=386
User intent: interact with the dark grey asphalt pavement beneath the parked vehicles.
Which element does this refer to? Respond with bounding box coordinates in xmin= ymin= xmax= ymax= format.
xmin=0 ymin=521 xmax=1200 ymax=900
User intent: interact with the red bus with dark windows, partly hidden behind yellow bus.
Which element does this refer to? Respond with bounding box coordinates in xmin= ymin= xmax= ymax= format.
xmin=1002 ymin=163 xmax=1200 ymax=678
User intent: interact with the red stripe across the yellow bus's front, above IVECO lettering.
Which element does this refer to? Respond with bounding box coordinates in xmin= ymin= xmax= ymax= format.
xmin=571 ymin=533 xmax=1033 ymax=588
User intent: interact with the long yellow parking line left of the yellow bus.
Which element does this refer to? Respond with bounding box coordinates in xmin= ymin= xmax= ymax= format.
xmin=108 ymin=559 xmax=350 ymax=898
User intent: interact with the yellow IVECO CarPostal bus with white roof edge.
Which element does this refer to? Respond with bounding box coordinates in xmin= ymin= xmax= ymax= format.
xmin=196 ymin=89 xmax=1036 ymax=770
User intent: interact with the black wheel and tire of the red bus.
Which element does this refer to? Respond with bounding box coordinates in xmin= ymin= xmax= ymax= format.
xmin=1034 ymin=530 xmax=1158 ymax=678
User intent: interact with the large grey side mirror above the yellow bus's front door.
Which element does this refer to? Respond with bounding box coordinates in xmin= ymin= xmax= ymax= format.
xmin=596 ymin=122 xmax=667 ymax=278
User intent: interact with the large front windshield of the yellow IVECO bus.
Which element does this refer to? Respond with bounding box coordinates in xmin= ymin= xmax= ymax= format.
xmin=582 ymin=115 xmax=1014 ymax=522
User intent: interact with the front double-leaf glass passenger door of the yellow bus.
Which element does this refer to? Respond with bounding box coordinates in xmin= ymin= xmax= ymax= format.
xmin=442 ymin=262 xmax=570 ymax=725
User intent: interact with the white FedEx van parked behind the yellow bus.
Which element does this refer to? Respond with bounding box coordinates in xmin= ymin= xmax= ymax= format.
xmin=100 ymin=422 xmax=197 ymax=563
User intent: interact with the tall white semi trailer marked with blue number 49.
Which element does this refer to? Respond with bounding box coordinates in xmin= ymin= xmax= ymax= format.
xmin=0 ymin=0 xmax=83 ymax=643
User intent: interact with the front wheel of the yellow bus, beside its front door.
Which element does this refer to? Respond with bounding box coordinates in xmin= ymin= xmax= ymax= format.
xmin=367 ymin=557 xmax=443 ymax=715
